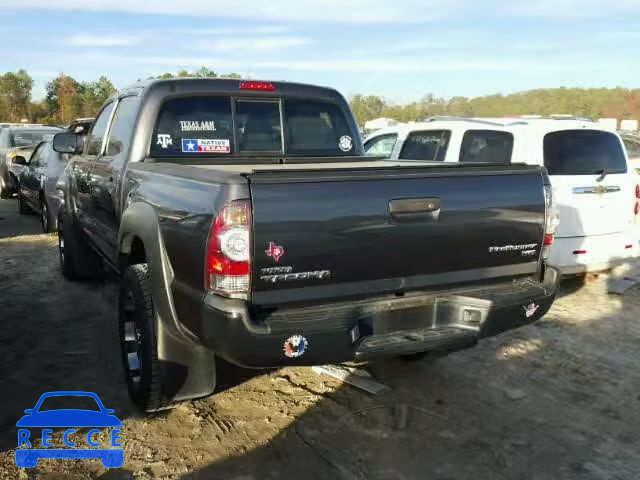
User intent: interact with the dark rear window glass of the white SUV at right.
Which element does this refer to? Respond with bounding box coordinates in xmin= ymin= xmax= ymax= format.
xmin=544 ymin=130 xmax=627 ymax=175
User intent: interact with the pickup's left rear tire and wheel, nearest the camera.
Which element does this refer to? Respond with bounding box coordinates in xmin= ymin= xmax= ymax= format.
xmin=118 ymin=263 xmax=173 ymax=412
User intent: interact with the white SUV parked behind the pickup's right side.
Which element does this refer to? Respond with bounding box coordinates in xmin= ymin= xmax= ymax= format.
xmin=365 ymin=118 xmax=640 ymax=275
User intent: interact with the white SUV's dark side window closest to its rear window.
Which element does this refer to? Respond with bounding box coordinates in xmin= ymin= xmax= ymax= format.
xmin=460 ymin=130 xmax=513 ymax=164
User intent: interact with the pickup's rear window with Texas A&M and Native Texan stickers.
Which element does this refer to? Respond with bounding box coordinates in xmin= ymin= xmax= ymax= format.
xmin=151 ymin=97 xmax=356 ymax=157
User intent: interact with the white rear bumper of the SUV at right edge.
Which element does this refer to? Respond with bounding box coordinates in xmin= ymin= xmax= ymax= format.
xmin=549 ymin=232 xmax=640 ymax=275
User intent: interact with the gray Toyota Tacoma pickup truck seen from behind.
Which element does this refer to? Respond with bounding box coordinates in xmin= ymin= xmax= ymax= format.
xmin=54 ymin=79 xmax=558 ymax=411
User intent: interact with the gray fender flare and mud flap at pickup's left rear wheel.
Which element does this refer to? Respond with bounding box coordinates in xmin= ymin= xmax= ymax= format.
xmin=118 ymin=202 xmax=216 ymax=400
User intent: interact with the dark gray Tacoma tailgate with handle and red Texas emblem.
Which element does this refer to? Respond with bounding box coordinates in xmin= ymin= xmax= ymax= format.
xmin=247 ymin=164 xmax=545 ymax=306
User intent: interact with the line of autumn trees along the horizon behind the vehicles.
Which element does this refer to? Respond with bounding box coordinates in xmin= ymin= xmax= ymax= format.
xmin=0 ymin=67 xmax=640 ymax=125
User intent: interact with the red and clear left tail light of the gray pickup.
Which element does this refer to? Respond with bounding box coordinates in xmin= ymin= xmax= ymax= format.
xmin=205 ymin=200 xmax=251 ymax=295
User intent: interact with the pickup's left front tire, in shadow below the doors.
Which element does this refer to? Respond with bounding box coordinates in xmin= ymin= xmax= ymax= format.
xmin=58 ymin=214 xmax=103 ymax=281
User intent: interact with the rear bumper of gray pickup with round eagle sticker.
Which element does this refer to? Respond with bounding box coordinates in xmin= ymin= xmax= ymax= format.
xmin=201 ymin=267 xmax=559 ymax=368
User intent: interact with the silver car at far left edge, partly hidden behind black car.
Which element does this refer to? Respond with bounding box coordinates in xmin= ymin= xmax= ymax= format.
xmin=0 ymin=126 xmax=63 ymax=198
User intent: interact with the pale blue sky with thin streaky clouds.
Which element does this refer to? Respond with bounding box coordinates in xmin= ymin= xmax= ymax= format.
xmin=0 ymin=0 xmax=640 ymax=103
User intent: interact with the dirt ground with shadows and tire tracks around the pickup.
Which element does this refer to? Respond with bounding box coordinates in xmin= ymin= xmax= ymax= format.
xmin=0 ymin=196 xmax=640 ymax=480
